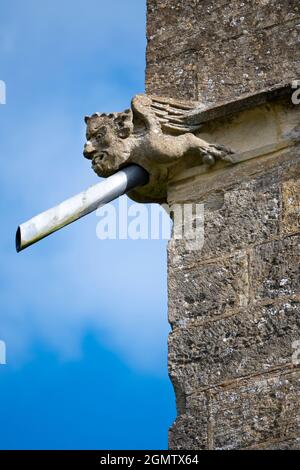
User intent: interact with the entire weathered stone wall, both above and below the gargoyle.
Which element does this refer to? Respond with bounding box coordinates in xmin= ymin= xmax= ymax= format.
xmin=147 ymin=0 xmax=300 ymax=449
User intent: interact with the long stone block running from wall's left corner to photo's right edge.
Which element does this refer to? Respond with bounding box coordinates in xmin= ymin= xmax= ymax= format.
xmin=169 ymin=301 xmax=300 ymax=395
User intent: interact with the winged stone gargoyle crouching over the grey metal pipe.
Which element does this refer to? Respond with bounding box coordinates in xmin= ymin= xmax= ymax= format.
xmin=84 ymin=95 xmax=232 ymax=202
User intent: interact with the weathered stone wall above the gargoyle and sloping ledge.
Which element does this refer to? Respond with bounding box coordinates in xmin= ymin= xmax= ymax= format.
xmin=146 ymin=0 xmax=300 ymax=103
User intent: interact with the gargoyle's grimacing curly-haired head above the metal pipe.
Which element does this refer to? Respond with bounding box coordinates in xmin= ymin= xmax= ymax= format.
xmin=83 ymin=110 xmax=133 ymax=177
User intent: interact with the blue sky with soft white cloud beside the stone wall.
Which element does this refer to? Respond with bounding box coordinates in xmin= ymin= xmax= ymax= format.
xmin=0 ymin=0 xmax=175 ymax=449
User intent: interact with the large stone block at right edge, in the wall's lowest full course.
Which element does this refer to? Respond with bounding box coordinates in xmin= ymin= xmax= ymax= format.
xmin=211 ymin=371 xmax=300 ymax=450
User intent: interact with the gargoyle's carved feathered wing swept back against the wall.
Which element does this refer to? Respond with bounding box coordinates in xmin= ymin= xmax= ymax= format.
xmin=132 ymin=95 xmax=201 ymax=135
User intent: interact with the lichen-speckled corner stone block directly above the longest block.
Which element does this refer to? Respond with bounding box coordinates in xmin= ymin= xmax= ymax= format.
xmin=169 ymin=253 xmax=249 ymax=325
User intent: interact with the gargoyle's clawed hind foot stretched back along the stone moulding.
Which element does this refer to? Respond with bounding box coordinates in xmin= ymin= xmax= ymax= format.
xmin=189 ymin=134 xmax=233 ymax=166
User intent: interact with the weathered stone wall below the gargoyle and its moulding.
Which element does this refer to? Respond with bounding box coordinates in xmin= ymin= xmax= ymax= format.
xmin=169 ymin=148 xmax=300 ymax=449
